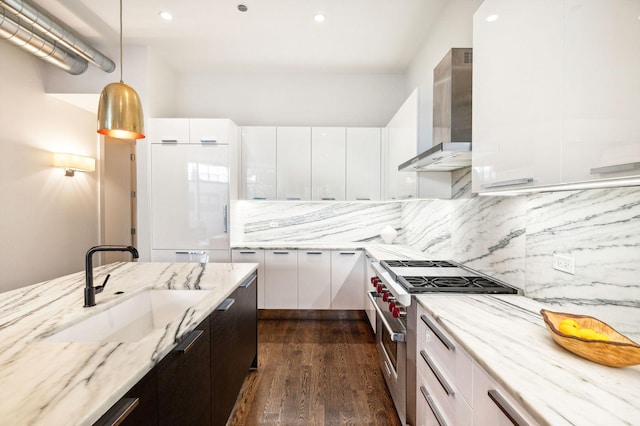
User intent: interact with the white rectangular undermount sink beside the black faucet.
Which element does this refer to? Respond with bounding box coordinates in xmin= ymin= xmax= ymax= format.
xmin=42 ymin=290 xmax=210 ymax=343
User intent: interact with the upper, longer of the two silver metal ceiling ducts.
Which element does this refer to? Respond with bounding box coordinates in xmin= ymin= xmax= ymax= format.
xmin=0 ymin=0 xmax=116 ymax=72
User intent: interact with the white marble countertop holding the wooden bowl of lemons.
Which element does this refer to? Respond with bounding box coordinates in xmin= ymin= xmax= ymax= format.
xmin=417 ymin=294 xmax=640 ymax=426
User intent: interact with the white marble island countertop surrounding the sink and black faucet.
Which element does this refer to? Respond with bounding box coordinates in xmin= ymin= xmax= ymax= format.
xmin=0 ymin=262 xmax=258 ymax=426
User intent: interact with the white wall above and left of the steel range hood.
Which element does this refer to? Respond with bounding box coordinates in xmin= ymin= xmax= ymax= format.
xmin=405 ymin=0 xmax=483 ymax=151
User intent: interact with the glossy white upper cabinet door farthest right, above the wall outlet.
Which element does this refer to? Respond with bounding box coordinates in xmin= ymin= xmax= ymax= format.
xmin=562 ymin=0 xmax=640 ymax=182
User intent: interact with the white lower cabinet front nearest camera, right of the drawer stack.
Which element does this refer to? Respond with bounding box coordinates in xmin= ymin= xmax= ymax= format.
xmin=473 ymin=362 xmax=538 ymax=426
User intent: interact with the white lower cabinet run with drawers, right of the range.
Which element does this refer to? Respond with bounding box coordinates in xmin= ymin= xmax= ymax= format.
xmin=416 ymin=305 xmax=537 ymax=426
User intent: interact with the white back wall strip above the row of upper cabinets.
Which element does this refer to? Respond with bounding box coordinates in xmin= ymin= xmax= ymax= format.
xmin=177 ymin=73 xmax=405 ymax=127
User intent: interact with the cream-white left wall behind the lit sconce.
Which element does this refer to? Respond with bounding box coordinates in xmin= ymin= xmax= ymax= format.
xmin=0 ymin=42 xmax=99 ymax=291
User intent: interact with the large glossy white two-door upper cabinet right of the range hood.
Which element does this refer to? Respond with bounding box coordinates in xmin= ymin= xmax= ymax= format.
xmin=473 ymin=0 xmax=640 ymax=192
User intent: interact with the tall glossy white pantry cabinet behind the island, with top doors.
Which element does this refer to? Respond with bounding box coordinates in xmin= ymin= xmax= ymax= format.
xmin=147 ymin=119 xmax=238 ymax=262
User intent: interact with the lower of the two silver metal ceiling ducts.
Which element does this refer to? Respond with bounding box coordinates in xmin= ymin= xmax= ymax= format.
xmin=0 ymin=7 xmax=89 ymax=74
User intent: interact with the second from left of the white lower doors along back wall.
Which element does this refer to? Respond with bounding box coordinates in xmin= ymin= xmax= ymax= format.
xmin=264 ymin=250 xmax=298 ymax=309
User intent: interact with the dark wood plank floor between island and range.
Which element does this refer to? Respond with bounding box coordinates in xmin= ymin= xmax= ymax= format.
xmin=228 ymin=311 xmax=400 ymax=426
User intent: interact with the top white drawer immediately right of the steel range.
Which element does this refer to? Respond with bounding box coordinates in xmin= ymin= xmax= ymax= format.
xmin=416 ymin=306 xmax=473 ymax=401
